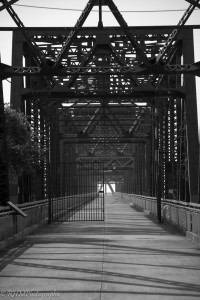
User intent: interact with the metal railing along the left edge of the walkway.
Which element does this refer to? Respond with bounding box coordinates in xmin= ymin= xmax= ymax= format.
xmin=0 ymin=194 xmax=102 ymax=249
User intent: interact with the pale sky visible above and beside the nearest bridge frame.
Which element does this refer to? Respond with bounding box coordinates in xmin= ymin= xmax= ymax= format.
xmin=0 ymin=0 xmax=200 ymax=136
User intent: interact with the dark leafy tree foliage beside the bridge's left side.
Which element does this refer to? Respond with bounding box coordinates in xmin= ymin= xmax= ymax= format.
xmin=5 ymin=105 xmax=44 ymax=175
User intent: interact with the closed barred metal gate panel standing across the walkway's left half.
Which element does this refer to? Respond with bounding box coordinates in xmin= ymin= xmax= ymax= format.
xmin=49 ymin=162 xmax=104 ymax=222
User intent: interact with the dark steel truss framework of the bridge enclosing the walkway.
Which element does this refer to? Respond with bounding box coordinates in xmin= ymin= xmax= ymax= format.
xmin=0 ymin=0 xmax=200 ymax=210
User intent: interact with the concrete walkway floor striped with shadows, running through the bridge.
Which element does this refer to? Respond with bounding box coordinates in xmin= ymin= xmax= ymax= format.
xmin=0 ymin=196 xmax=200 ymax=300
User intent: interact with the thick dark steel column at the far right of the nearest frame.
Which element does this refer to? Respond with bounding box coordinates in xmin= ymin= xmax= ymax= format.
xmin=183 ymin=29 xmax=199 ymax=203
